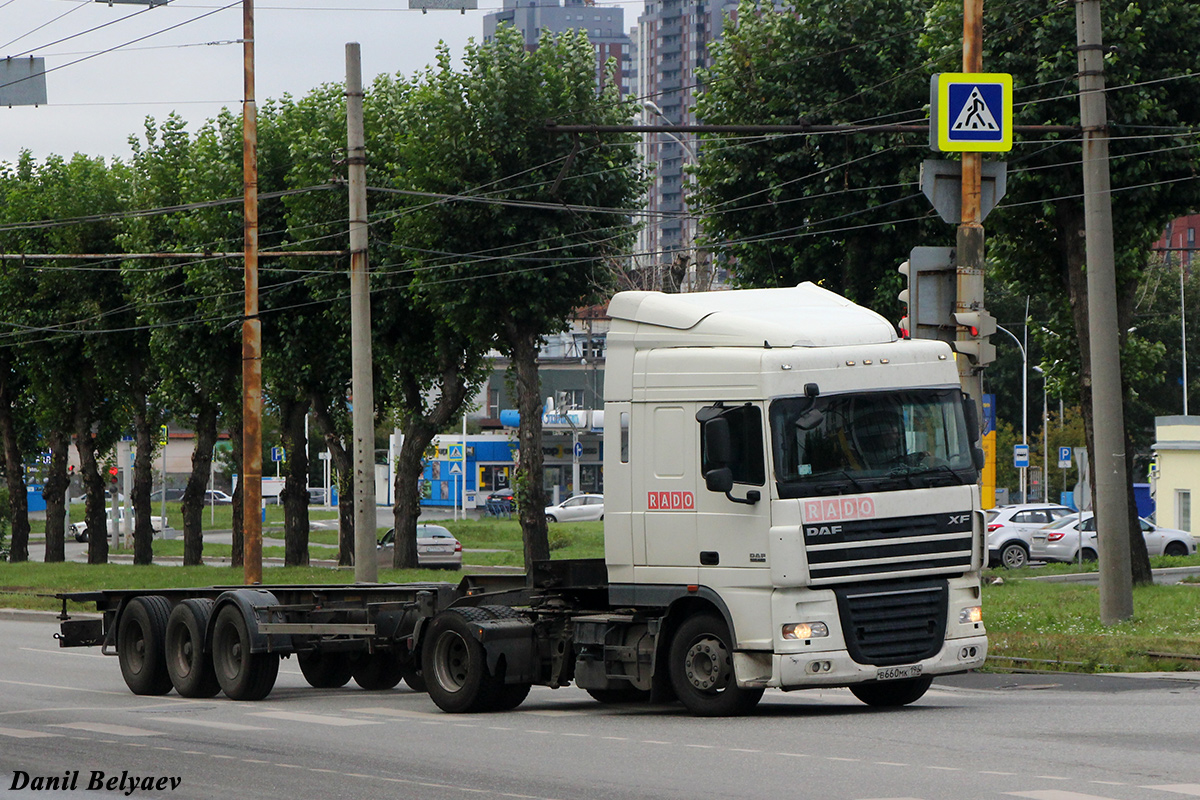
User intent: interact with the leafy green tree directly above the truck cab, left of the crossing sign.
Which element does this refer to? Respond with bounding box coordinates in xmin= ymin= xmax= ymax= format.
xmin=689 ymin=0 xmax=945 ymax=309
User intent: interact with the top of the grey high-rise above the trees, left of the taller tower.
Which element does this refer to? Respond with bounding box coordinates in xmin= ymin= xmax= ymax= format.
xmin=484 ymin=0 xmax=630 ymax=95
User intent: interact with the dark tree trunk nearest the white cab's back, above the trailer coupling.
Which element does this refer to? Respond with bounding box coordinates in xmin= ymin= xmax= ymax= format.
xmin=509 ymin=325 xmax=550 ymax=579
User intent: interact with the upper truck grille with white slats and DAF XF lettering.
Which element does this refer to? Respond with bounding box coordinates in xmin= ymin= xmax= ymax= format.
xmin=803 ymin=512 xmax=972 ymax=585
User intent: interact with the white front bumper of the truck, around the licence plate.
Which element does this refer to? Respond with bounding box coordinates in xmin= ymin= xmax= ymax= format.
xmin=777 ymin=634 xmax=988 ymax=691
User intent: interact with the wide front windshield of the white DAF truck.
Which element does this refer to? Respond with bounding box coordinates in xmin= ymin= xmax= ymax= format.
xmin=770 ymin=389 xmax=976 ymax=498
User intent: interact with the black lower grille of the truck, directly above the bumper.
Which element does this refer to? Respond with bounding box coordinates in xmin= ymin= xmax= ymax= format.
xmin=834 ymin=581 xmax=947 ymax=666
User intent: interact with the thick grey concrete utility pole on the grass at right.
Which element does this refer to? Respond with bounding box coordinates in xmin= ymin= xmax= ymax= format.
xmin=1075 ymin=0 xmax=1133 ymax=625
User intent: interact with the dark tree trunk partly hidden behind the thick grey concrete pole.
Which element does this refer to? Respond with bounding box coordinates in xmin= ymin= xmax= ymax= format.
xmin=1056 ymin=203 xmax=1154 ymax=585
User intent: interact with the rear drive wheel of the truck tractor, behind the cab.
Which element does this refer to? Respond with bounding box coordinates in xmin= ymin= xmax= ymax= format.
xmin=421 ymin=608 xmax=501 ymax=714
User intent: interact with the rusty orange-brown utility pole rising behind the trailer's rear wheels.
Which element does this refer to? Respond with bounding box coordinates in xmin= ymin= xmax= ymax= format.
xmin=241 ymin=0 xmax=263 ymax=585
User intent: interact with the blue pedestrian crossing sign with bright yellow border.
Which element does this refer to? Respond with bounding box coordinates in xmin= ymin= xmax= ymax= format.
xmin=929 ymin=72 xmax=1013 ymax=152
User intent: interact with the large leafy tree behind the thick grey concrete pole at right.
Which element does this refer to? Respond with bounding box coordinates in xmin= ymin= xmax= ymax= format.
xmin=926 ymin=0 xmax=1200 ymax=583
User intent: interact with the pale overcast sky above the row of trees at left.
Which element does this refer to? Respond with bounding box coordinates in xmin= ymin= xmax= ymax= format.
xmin=0 ymin=0 xmax=642 ymax=163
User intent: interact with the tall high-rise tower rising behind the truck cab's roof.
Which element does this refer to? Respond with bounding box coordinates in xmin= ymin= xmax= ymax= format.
xmin=634 ymin=0 xmax=738 ymax=289
